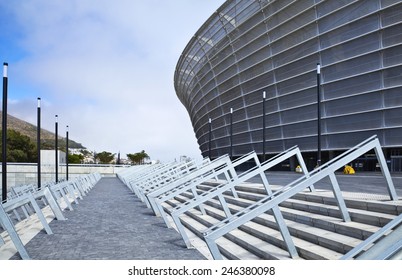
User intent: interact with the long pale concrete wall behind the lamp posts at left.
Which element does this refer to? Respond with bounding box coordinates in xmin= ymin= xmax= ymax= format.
xmin=0 ymin=161 xmax=129 ymax=191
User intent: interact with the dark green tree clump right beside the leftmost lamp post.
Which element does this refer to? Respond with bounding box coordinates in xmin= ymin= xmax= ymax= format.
xmin=0 ymin=129 xmax=37 ymax=163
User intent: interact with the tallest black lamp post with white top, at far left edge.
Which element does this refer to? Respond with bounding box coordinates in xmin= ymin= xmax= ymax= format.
xmin=1 ymin=62 xmax=8 ymax=202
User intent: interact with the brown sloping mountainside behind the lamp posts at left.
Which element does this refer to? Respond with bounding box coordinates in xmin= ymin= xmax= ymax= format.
xmin=0 ymin=111 xmax=85 ymax=149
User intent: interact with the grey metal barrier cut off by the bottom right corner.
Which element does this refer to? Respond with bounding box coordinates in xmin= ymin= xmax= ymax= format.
xmin=340 ymin=214 xmax=402 ymax=260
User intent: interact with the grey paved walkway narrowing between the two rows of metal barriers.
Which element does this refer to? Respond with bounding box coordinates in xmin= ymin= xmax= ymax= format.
xmin=12 ymin=177 xmax=205 ymax=260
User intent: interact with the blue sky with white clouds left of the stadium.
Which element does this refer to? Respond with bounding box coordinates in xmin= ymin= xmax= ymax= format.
xmin=0 ymin=0 xmax=225 ymax=162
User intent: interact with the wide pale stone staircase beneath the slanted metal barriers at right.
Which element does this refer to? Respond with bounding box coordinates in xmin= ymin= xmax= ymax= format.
xmin=158 ymin=180 xmax=402 ymax=260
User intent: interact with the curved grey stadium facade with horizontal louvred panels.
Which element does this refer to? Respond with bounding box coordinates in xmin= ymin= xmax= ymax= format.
xmin=174 ymin=0 xmax=402 ymax=171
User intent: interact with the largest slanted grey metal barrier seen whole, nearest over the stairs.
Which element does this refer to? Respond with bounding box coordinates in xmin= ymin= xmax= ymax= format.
xmin=201 ymin=135 xmax=398 ymax=259
